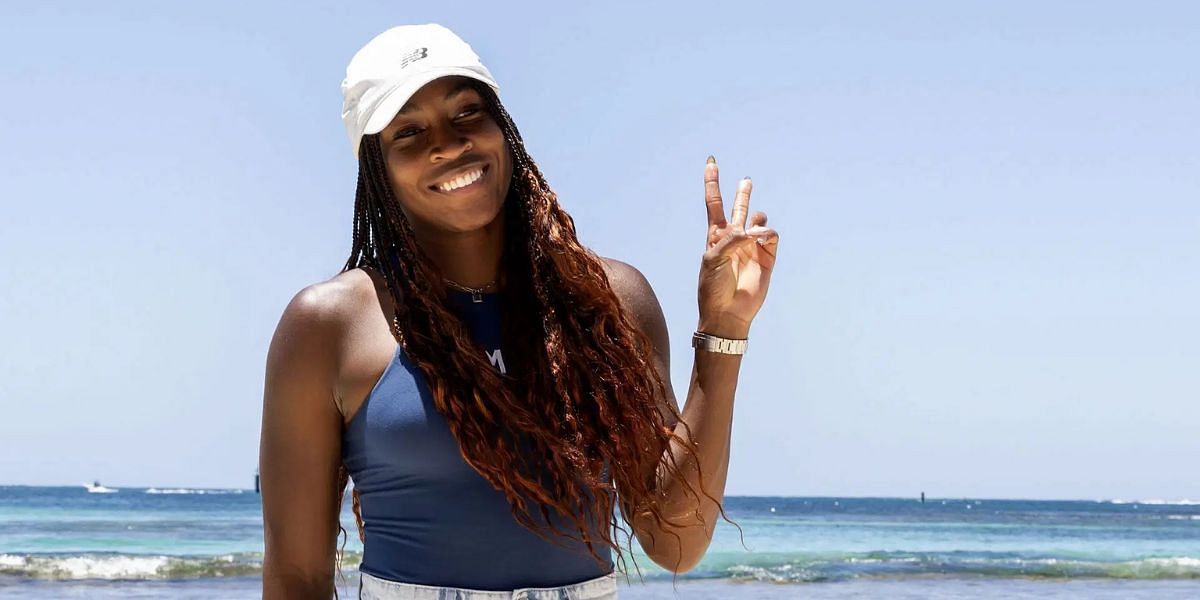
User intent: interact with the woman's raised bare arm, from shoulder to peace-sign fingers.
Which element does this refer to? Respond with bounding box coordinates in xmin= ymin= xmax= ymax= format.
xmin=608 ymin=156 xmax=779 ymax=572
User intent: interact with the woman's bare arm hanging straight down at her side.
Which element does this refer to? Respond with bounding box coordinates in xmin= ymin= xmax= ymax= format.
xmin=259 ymin=284 xmax=342 ymax=600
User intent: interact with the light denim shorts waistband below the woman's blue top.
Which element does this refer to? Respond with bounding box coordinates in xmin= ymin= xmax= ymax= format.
xmin=359 ymin=571 xmax=617 ymax=600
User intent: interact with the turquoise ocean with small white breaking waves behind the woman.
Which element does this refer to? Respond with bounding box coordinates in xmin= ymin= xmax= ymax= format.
xmin=0 ymin=486 xmax=1200 ymax=600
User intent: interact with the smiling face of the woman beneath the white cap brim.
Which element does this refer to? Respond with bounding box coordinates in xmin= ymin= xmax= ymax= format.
xmin=379 ymin=77 xmax=512 ymax=236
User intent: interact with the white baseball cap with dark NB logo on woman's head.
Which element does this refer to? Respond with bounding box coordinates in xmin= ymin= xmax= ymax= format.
xmin=342 ymin=23 xmax=500 ymax=158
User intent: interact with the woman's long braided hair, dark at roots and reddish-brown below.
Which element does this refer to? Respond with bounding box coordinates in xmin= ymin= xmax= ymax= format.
xmin=338 ymin=82 xmax=732 ymax=572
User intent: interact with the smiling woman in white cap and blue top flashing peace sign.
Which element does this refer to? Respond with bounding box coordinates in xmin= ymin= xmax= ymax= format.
xmin=260 ymin=24 xmax=779 ymax=599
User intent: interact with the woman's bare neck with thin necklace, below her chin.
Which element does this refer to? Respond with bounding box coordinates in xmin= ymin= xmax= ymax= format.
xmin=414 ymin=212 xmax=504 ymax=292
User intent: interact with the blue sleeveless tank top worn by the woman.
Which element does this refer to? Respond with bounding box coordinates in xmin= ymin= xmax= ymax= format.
xmin=342 ymin=290 xmax=613 ymax=590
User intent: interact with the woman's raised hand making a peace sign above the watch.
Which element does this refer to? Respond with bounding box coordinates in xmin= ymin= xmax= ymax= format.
xmin=698 ymin=156 xmax=779 ymax=338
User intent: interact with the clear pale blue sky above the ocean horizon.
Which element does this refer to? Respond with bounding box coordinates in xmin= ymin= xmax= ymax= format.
xmin=0 ymin=1 xmax=1200 ymax=499
